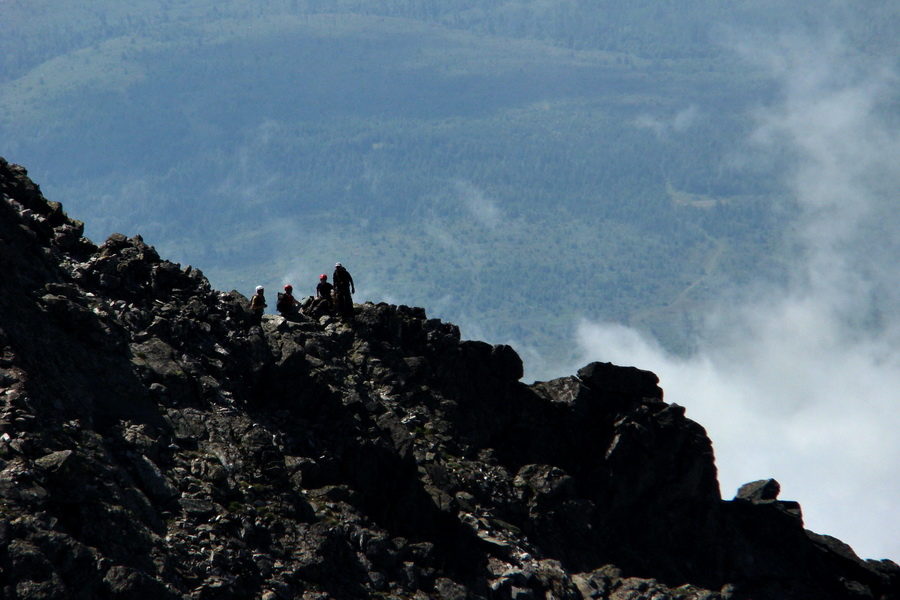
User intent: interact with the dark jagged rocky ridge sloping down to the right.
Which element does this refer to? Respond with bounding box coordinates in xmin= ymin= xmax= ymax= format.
xmin=0 ymin=160 xmax=900 ymax=600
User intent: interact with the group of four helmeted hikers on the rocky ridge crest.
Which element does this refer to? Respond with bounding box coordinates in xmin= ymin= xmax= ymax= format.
xmin=250 ymin=263 xmax=356 ymax=325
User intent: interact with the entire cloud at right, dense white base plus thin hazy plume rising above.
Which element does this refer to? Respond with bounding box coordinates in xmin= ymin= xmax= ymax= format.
xmin=578 ymin=27 xmax=900 ymax=560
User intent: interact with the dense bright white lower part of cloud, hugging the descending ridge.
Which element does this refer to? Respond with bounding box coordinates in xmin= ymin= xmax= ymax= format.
xmin=578 ymin=304 xmax=900 ymax=560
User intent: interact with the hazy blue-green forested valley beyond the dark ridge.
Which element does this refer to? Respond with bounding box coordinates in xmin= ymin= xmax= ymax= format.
xmin=0 ymin=0 xmax=900 ymax=376
